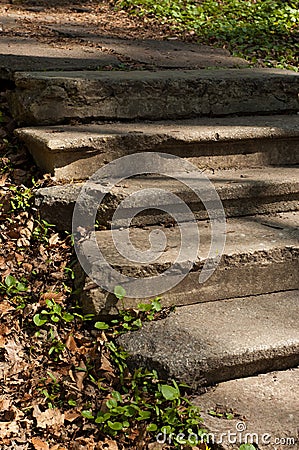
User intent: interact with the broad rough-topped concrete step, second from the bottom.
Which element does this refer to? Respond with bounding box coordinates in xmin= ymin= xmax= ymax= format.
xmin=118 ymin=290 xmax=299 ymax=388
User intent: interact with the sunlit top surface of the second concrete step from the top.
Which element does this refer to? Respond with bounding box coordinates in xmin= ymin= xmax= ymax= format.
xmin=15 ymin=114 xmax=299 ymax=149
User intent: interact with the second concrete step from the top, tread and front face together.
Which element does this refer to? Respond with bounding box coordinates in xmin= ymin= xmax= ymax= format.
xmin=16 ymin=114 xmax=299 ymax=180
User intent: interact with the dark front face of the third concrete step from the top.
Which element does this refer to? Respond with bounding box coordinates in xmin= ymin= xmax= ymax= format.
xmin=35 ymin=183 xmax=299 ymax=231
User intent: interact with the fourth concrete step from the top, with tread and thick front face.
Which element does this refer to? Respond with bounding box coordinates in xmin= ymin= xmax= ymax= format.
xmin=78 ymin=212 xmax=299 ymax=314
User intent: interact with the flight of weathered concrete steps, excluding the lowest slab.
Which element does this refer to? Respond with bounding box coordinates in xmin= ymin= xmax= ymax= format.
xmin=9 ymin=68 xmax=299 ymax=449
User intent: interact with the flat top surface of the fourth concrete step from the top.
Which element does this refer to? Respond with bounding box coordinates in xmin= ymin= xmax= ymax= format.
xmin=82 ymin=211 xmax=299 ymax=273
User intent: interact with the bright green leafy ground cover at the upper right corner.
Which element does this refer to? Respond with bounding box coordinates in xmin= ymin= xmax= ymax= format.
xmin=117 ymin=0 xmax=299 ymax=71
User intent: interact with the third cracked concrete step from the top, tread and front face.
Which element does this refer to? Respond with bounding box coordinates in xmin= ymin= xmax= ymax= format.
xmin=35 ymin=166 xmax=299 ymax=231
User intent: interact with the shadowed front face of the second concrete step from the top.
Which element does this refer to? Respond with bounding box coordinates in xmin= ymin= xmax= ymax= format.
xmin=20 ymin=134 xmax=299 ymax=181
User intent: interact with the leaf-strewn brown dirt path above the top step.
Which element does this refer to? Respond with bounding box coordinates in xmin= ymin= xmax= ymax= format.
xmin=0 ymin=1 xmax=248 ymax=74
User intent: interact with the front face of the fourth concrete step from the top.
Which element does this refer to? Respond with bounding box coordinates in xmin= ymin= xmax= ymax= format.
xmin=81 ymin=249 xmax=299 ymax=315
